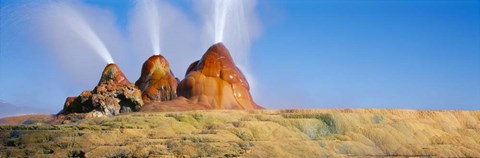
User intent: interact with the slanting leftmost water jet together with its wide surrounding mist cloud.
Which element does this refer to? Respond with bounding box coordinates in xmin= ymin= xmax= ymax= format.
xmin=30 ymin=1 xmax=128 ymax=87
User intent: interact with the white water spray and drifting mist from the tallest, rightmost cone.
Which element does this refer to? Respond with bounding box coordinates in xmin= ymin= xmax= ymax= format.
xmin=193 ymin=0 xmax=261 ymax=100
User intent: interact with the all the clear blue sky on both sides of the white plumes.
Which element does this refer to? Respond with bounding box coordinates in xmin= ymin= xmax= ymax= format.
xmin=0 ymin=0 xmax=480 ymax=115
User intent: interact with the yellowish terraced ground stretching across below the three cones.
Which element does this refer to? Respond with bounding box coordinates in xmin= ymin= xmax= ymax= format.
xmin=0 ymin=109 xmax=480 ymax=157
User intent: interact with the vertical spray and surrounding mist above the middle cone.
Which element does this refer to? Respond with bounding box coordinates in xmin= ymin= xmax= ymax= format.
xmin=129 ymin=0 xmax=201 ymax=76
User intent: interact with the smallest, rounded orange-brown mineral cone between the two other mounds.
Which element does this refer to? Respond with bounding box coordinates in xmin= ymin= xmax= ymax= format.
xmin=135 ymin=55 xmax=178 ymax=103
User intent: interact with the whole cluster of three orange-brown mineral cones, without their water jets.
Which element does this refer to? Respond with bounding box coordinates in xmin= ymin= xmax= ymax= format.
xmin=59 ymin=43 xmax=263 ymax=115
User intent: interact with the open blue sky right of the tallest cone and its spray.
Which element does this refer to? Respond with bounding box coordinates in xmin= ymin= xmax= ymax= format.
xmin=252 ymin=1 xmax=480 ymax=109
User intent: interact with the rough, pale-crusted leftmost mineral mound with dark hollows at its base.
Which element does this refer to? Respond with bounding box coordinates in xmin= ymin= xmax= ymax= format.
xmin=59 ymin=64 xmax=143 ymax=117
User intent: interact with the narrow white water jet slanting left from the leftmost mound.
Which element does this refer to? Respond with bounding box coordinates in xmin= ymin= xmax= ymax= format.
xmin=46 ymin=3 xmax=114 ymax=63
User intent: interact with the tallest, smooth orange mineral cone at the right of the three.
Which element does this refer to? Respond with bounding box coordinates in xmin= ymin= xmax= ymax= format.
xmin=177 ymin=43 xmax=263 ymax=109
